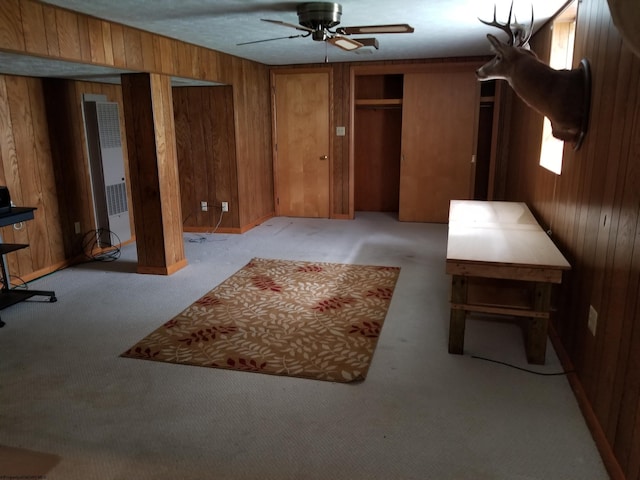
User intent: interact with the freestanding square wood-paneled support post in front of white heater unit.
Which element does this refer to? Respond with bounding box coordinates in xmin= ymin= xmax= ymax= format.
xmin=122 ymin=73 xmax=187 ymax=275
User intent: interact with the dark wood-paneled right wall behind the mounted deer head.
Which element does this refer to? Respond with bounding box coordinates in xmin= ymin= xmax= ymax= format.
xmin=505 ymin=0 xmax=640 ymax=480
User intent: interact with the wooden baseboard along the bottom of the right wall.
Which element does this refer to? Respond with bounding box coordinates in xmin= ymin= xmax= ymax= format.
xmin=549 ymin=324 xmax=626 ymax=480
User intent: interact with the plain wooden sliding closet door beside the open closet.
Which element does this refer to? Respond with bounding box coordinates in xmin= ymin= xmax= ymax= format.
xmin=398 ymin=70 xmax=478 ymax=223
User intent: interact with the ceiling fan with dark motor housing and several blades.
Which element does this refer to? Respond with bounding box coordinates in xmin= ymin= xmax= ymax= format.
xmin=238 ymin=2 xmax=413 ymax=51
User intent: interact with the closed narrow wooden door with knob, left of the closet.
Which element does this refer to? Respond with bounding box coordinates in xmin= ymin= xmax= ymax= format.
xmin=274 ymin=70 xmax=331 ymax=218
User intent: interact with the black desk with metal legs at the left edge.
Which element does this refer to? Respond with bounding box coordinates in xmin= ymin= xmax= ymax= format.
xmin=0 ymin=207 xmax=57 ymax=327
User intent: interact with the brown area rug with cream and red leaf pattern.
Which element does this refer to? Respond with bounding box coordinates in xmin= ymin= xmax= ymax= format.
xmin=122 ymin=258 xmax=400 ymax=382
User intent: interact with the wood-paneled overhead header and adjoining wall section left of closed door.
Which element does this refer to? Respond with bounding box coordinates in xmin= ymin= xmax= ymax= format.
xmin=0 ymin=0 xmax=274 ymax=228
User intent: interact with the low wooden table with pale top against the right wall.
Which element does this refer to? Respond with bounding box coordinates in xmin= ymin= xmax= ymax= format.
xmin=446 ymin=200 xmax=571 ymax=364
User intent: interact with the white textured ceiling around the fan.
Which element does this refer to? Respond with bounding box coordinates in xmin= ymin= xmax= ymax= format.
xmin=0 ymin=0 xmax=568 ymax=78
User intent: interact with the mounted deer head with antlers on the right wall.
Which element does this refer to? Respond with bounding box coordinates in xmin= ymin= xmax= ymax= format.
xmin=476 ymin=4 xmax=591 ymax=150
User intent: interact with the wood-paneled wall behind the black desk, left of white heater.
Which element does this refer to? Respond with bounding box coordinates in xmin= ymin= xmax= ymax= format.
xmin=0 ymin=75 xmax=127 ymax=280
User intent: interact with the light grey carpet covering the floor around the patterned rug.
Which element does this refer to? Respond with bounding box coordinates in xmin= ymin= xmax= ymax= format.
xmin=0 ymin=212 xmax=608 ymax=480
